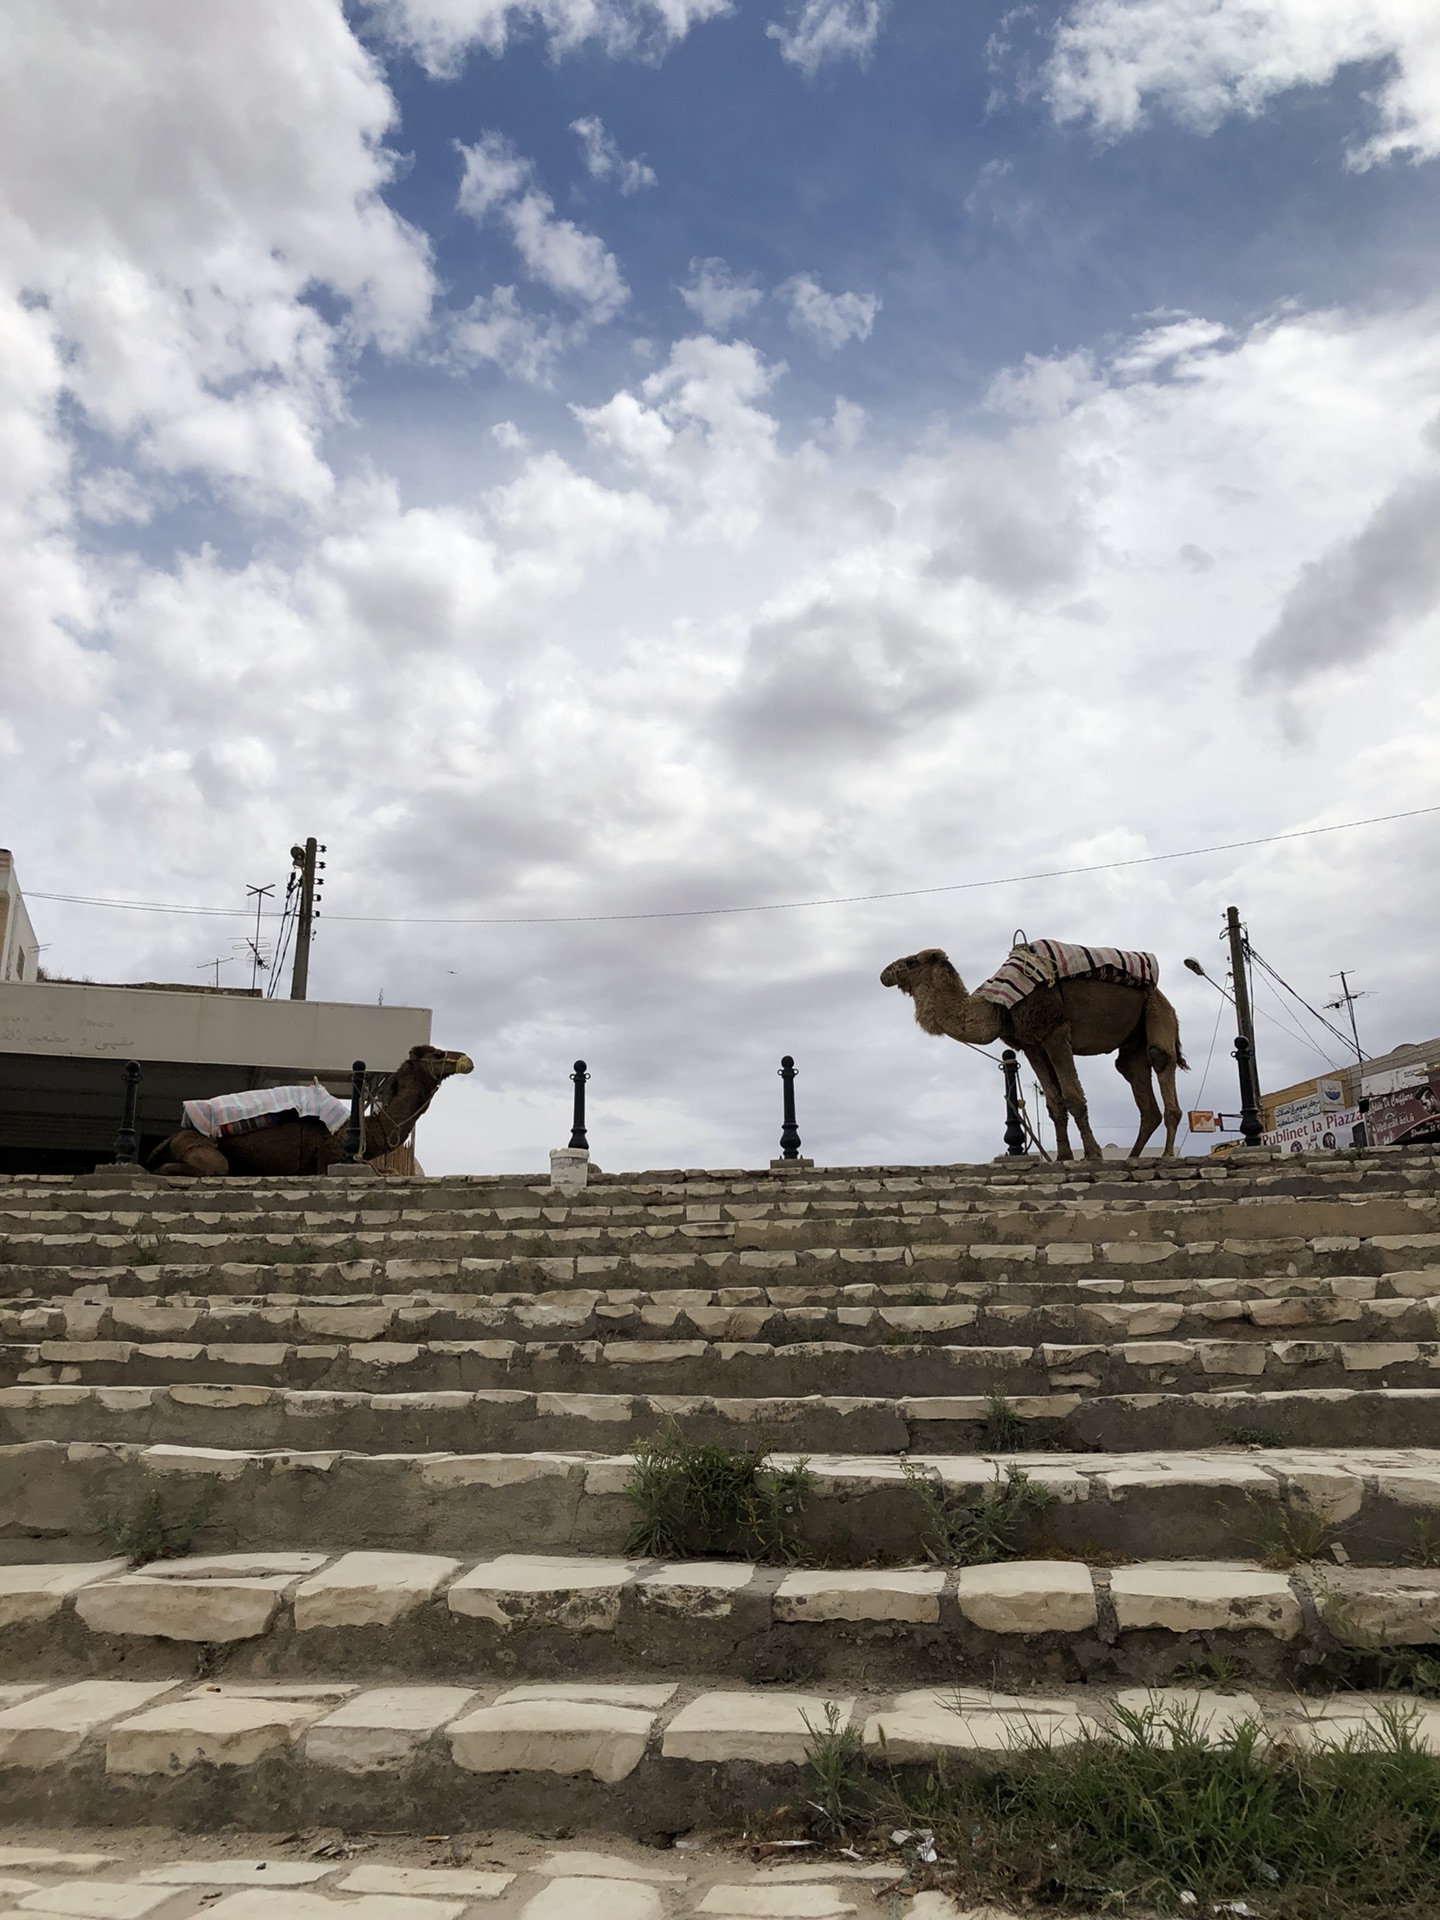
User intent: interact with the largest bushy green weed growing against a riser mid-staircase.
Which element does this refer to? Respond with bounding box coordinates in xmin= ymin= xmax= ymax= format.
xmin=624 ymin=1427 xmax=814 ymax=1567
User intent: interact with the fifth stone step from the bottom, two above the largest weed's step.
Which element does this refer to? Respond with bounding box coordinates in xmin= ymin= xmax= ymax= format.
xmin=0 ymin=1323 xmax=1440 ymax=1400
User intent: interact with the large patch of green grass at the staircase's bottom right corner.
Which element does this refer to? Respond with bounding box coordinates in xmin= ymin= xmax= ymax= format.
xmin=867 ymin=1711 xmax=1440 ymax=1920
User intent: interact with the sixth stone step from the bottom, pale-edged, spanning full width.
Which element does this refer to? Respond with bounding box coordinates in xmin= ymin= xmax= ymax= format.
xmin=11 ymin=1267 xmax=1440 ymax=1344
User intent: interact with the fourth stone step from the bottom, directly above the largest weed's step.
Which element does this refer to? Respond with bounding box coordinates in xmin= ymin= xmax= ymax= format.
xmin=0 ymin=1382 xmax=1440 ymax=1453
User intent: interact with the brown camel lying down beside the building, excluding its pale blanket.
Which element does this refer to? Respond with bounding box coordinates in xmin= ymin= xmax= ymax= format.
xmin=148 ymin=1046 xmax=474 ymax=1175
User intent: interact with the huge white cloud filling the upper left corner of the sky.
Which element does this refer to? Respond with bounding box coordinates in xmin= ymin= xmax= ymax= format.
xmin=0 ymin=0 xmax=434 ymax=507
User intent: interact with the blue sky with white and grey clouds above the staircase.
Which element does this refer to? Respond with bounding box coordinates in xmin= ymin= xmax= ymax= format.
xmin=0 ymin=0 xmax=1440 ymax=1171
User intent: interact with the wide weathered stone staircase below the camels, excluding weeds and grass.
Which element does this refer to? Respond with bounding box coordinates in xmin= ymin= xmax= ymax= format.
xmin=0 ymin=1148 xmax=1440 ymax=1850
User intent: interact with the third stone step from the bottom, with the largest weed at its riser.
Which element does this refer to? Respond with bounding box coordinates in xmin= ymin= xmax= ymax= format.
xmin=0 ymin=1440 xmax=1440 ymax=1567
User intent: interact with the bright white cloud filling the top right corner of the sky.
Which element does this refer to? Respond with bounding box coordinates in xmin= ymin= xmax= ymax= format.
xmin=1044 ymin=0 xmax=1440 ymax=167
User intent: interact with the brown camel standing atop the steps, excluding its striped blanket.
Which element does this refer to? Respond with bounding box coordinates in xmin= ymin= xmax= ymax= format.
xmin=879 ymin=947 xmax=1187 ymax=1160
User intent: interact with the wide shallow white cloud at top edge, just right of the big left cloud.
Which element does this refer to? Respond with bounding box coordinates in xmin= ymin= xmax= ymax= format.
xmin=371 ymin=0 xmax=730 ymax=77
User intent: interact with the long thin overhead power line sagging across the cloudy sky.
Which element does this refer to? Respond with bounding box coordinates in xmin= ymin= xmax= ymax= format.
xmin=27 ymin=804 xmax=1440 ymax=927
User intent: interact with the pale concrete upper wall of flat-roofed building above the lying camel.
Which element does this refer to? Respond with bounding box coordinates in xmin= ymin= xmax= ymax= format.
xmin=0 ymin=981 xmax=430 ymax=1077
